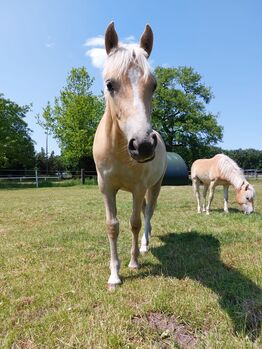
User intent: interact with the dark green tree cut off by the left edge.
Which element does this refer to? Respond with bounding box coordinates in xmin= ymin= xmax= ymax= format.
xmin=0 ymin=94 xmax=35 ymax=169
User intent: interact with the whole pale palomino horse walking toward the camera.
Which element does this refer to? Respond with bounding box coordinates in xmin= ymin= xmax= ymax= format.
xmin=93 ymin=22 xmax=166 ymax=289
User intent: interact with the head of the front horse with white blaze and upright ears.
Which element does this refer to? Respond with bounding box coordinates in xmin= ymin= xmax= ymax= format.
xmin=103 ymin=23 xmax=157 ymax=162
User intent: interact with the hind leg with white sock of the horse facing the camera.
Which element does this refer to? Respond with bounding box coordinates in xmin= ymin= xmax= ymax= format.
xmin=140 ymin=178 xmax=162 ymax=252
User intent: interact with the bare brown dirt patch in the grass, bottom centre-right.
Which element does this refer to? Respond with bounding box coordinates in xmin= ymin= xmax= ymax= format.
xmin=133 ymin=313 xmax=197 ymax=349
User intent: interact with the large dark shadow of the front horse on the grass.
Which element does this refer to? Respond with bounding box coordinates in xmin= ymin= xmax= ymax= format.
xmin=137 ymin=232 xmax=262 ymax=340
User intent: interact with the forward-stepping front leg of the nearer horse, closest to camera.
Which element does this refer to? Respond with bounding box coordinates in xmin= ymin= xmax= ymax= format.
xmin=103 ymin=190 xmax=121 ymax=289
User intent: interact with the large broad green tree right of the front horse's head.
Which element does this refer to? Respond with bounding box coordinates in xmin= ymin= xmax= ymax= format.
xmin=152 ymin=67 xmax=223 ymax=166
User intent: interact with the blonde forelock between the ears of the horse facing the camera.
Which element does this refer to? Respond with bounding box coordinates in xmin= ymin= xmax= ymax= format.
xmin=103 ymin=44 xmax=151 ymax=79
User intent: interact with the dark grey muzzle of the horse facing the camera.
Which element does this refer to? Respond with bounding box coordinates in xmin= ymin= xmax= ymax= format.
xmin=128 ymin=132 xmax=157 ymax=163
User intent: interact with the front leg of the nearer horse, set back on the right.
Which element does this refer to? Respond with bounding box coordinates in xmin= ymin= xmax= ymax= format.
xmin=128 ymin=190 xmax=145 ymax=269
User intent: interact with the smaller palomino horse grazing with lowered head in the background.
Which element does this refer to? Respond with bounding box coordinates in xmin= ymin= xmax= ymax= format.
xmin=191 ymin=154 xmax=255 ymax=214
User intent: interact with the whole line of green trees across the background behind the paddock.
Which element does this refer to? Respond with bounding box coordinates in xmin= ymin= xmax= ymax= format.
xmin=0 ymin=67 xmax=262 ymax=172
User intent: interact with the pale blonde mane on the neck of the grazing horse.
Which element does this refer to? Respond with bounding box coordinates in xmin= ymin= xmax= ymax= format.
xmin=217 ymin=154 xmax=246 ymax=189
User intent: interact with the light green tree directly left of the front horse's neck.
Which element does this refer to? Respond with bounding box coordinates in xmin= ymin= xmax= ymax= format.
xmin=42 ymin=67 xmax=103 ymax=168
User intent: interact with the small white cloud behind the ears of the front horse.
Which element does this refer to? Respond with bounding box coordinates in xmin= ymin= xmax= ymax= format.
xmin=84 ymin=35 xmax=135 ymax=70
